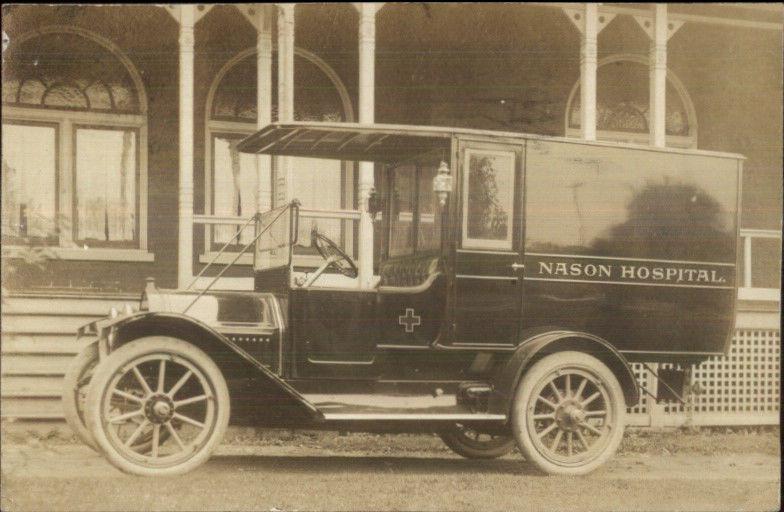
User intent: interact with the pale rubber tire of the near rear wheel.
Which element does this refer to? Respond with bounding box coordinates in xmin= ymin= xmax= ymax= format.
xmin=512 ymin=351 xmax=626 ymax=475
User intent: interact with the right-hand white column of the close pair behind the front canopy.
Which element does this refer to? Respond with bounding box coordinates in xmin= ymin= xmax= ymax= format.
xmin=273 ymin=4 xmax=295 ymax=205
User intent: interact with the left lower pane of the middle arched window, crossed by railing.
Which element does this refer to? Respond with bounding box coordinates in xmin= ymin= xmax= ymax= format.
xmin=212 ymin=135 xmax=260 ymax=244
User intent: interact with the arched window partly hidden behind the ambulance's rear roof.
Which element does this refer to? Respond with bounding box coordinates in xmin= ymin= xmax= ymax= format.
xmin=566 ymin=55 xmax=697 ymax=148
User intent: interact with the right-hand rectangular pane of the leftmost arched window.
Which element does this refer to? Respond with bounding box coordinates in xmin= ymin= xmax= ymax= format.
xmin=75 ymin=128 xmax=137 ymax=246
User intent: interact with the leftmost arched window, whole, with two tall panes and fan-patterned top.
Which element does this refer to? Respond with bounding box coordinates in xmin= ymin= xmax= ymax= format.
xmin=2 ymin=27 xmax=147 ymax=259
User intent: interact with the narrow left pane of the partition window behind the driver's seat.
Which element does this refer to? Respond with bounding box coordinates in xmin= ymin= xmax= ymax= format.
xmin=389 ymin=165 xmax=416 ymax=257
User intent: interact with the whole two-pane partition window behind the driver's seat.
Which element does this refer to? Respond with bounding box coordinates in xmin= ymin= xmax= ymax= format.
xmin=387 ymin=161 xmax=441 ymax=258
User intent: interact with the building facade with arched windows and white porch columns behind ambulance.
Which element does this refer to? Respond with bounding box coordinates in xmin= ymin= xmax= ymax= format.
xmin=2 ymin=3 xmax=783 ymax=417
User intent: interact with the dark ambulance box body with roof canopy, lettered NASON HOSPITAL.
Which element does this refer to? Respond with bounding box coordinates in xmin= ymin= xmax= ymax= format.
xmin=240 ymin=122 xmax=743 ymax=366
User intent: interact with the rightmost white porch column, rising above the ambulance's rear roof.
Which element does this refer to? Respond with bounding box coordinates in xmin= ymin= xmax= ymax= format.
xmin=648 ymin=4 xmax=668 ymax=147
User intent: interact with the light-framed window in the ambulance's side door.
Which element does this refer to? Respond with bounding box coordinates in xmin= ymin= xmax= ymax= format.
xmin=463 ymin=150 xmax=514 ymax=249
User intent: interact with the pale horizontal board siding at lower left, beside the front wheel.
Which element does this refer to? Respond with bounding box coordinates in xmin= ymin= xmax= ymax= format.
xmin=0 ymin=295 xmax=139 ymax=419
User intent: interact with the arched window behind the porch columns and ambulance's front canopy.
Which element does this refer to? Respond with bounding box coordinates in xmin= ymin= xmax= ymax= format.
xmin=202 ymin=48 xmax=354 ymax=260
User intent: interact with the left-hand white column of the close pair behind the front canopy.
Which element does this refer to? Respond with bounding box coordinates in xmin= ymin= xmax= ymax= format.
xmin=255 ymin=5 xmax=273 ymax=212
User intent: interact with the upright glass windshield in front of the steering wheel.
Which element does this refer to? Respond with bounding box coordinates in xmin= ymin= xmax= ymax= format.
xmin=253 ymin=202 xmax=299 ymax=270
